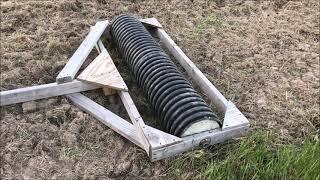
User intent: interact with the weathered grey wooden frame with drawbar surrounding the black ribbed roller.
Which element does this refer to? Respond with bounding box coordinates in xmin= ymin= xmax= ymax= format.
xmin=0 ymin=18 xmax=249 ymax=161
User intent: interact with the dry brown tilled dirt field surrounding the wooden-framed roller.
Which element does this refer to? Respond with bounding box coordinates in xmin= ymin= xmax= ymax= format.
xmin=0 ymin=0 xmax=320 ymax=179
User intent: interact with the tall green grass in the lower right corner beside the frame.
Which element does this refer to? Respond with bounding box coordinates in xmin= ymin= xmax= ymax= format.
xmin=169 ymin=132 xmax=320 ymax=180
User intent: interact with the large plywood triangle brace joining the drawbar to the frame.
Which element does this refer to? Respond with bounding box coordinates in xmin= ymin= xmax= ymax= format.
xmin=77 ymin=50 xmax=128 ymax=91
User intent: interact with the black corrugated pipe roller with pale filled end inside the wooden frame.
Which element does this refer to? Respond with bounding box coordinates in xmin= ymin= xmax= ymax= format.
xmin=111 ymin=15 xmax=220 ymax=137
